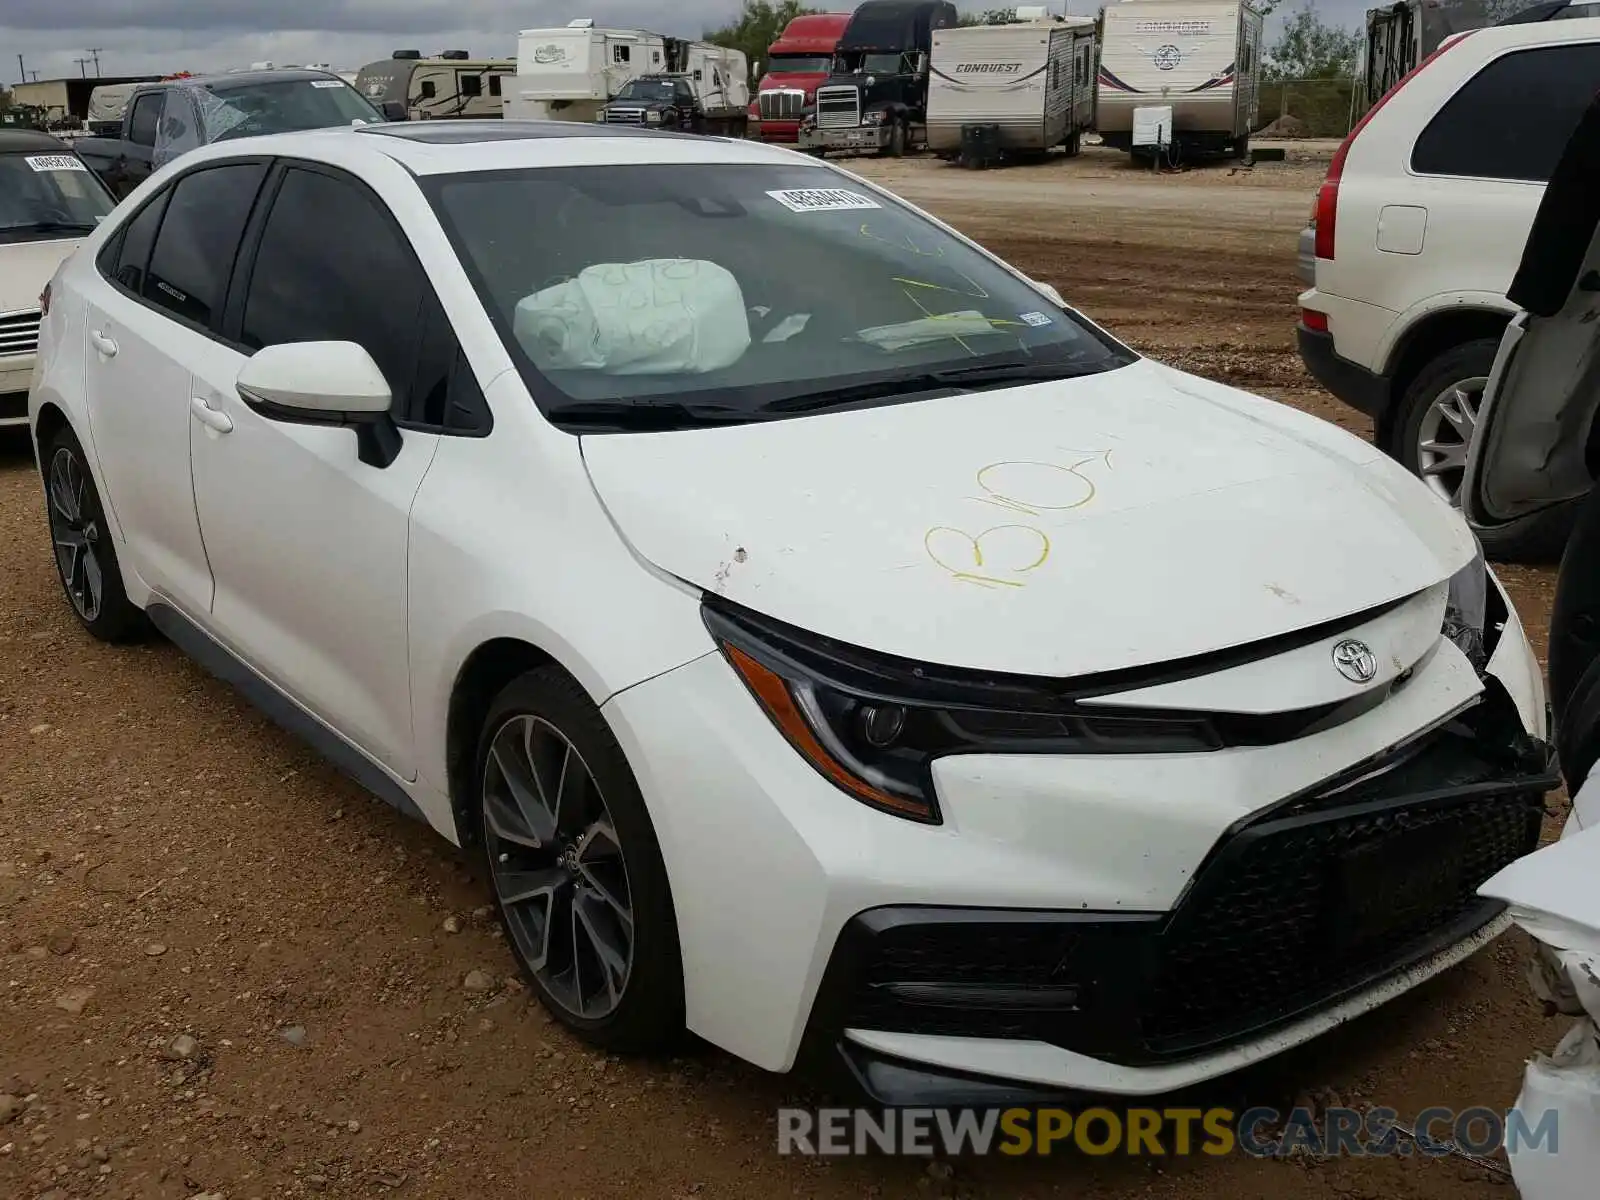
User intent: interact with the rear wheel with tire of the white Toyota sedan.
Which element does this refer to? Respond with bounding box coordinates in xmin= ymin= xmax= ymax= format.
xmin=43 ymin=426 xmax=147 ymax=643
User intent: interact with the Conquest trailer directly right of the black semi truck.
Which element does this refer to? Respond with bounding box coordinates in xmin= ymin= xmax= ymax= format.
xmin=928 ymin=16 xmax=1094 ymax=157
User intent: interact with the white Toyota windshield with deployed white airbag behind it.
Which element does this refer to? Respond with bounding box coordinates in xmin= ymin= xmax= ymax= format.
xmin=424 ymin=163 xmax=1133 ymax=424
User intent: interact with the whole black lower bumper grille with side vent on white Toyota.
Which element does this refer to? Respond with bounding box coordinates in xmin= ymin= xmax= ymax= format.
xmin=813 ymin=720 xmax=1555 ymax=1066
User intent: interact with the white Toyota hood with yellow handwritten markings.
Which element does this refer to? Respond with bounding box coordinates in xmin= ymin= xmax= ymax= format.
xmin=582 ymin=360 xmax=1475 ymax=675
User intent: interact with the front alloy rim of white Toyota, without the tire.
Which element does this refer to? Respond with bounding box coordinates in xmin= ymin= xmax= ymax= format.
xmin=483 ymin=714 xmax=634 ymax=1021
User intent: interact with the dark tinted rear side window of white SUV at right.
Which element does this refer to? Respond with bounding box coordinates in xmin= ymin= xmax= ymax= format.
xmin=1411 ymin=42 xmax=1600 ymax=182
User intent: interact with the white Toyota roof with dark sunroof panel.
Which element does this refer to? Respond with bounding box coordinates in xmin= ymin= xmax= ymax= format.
xmin=184 ymin=120 xmax=819 ymax=176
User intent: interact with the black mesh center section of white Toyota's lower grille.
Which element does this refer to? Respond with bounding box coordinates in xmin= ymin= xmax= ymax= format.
xmin=1142 ymin=792 xmax=1544 ymax=1056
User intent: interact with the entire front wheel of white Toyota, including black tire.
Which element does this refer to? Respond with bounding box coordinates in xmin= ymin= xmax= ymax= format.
xmin=475 ymin=667 xmax=683 ymax=1053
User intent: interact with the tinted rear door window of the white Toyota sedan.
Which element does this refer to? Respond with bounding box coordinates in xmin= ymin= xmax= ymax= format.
xmin=141 ymin=163 xmax=267 ymax=328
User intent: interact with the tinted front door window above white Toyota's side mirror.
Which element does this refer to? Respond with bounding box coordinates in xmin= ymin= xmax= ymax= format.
xmin=240 ymin=171 xmax=427 ymax=414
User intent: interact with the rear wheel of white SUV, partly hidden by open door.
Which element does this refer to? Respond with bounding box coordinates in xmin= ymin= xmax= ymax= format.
xmin=1384 ymin=338 xmax=1579 ymax=562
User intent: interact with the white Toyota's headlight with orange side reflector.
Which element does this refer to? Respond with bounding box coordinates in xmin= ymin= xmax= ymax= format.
xmin=702 ymin=600 xmax=1221 ymax=824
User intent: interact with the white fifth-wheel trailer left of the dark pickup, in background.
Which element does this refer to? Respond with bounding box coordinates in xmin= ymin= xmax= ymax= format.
xmin=506 ymin=18 xmax=667 ymax=122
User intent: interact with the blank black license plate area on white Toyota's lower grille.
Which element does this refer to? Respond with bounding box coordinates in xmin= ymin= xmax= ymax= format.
xmin=1328 ymin=822 xmax=1466 ymax=946
